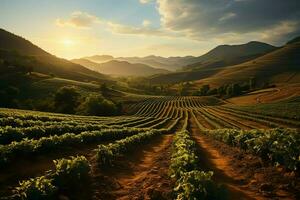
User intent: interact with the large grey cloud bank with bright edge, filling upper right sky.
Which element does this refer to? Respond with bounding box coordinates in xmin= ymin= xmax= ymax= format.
xmin=157 ymin=0 xmax=300 ymax=42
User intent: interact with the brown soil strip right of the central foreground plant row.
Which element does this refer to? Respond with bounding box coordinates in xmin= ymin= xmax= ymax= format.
xmin=190 ymin=115 xmax=299 ymax=200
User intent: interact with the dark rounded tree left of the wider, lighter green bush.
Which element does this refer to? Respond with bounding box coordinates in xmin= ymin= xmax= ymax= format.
xmin=54 ymin=86 xmax=80 ymax=114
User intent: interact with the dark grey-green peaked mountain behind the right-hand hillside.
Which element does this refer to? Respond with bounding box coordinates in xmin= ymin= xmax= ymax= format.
xmin=183 ymin=41 xmax=276 ymax=70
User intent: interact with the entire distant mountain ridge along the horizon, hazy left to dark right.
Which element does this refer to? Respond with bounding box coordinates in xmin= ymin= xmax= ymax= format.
xmin=83 ymin=41 xmax=276 ymax=71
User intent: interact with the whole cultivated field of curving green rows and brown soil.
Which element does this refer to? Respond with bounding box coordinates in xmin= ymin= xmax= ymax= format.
xmin=0 ymin=97 xmax=300 ymax=200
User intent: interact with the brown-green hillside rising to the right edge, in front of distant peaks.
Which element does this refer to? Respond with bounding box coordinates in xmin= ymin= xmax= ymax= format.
xmin=198 ymin=41 xmax=300 ymax=88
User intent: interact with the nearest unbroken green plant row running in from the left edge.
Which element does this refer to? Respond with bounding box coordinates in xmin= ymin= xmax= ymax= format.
xmin=0 ymin=128 xmax=149 ymax=167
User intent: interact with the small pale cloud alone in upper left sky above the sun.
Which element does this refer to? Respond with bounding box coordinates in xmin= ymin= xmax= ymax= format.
xmin=56 ymin=11 xmax=101 ymax=28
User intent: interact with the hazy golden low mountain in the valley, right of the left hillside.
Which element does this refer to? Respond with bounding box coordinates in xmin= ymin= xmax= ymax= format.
xmin=72 ymin=59 xmax=169 ymax=76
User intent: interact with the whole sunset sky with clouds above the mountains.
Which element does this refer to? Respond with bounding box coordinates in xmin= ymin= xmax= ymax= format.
xmin=0 ymin=0 xmax=300 ymax=59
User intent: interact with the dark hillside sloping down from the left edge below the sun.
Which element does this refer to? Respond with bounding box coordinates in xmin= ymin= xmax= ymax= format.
xmin=0 ymin=29 xmax=108 ymax=81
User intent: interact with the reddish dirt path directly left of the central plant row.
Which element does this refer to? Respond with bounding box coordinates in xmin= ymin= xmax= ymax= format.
xmin=93 ymin=135 xmax=173 ymax=200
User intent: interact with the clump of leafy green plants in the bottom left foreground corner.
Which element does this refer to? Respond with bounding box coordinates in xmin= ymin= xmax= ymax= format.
xmin=12 ymin=156 xmax=91 ymax=200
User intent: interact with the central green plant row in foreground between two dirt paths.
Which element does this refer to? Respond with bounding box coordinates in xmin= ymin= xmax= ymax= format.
xmin=169 ymin=131 xmax=226 ymax=200
